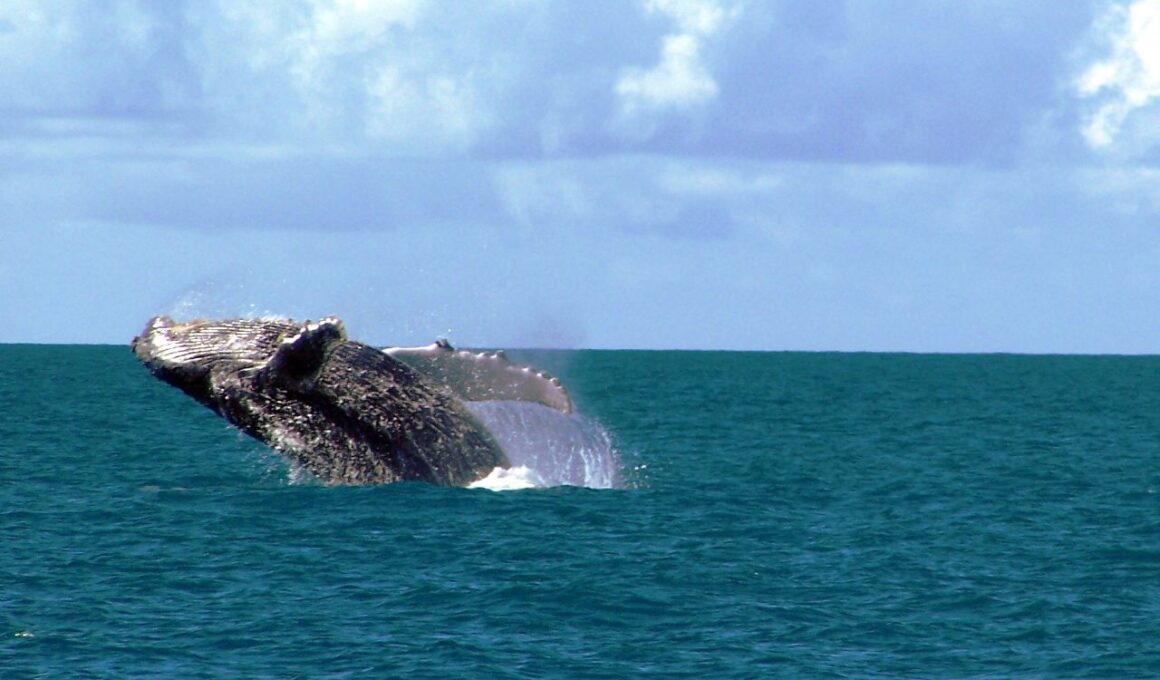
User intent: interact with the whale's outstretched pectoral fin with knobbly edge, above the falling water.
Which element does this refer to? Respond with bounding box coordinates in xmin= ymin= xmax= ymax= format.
xmin=383 ymin=340 xmax=572 ymax=413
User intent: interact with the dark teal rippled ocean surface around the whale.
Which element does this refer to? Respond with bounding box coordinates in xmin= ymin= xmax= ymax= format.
xmin=0 ymin=345 xmax=1160 ymax=679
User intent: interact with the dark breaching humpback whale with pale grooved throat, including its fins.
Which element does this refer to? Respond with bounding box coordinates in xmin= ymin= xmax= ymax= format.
xmin=132 ymin=317 xmax=572 ymax=486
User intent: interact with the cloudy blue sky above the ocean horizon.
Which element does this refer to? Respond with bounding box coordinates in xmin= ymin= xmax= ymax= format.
xmin=0 ymin=0 xmax=1160 ymax=354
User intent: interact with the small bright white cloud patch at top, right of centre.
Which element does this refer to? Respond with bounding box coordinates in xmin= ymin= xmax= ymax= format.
xmin=616 ymin=0 xmax=730 ymax=114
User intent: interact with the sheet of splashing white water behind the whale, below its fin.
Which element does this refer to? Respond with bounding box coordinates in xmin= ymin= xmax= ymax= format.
xmin=467 ymin=402 xmax=621 ymax=491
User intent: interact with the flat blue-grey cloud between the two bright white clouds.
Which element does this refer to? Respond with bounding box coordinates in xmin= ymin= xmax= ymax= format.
xmin=702 ymin=0 xmax=1092 ymax=164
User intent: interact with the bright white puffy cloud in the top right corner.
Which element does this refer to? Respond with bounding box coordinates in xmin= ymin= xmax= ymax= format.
xmin=1075 ymin=0 xmax=1160 ymax=149
